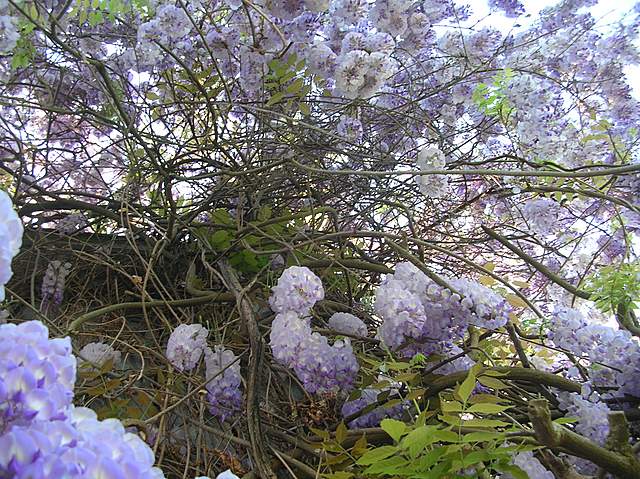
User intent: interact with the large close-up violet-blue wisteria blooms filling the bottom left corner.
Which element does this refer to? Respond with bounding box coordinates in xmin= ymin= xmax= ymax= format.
xmin=0 ymin=321 xmax=164 ymax=479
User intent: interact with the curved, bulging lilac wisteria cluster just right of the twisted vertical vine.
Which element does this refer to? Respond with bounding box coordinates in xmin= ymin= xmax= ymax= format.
xmin=269 ymin=266 xmax=366 ymax=394
